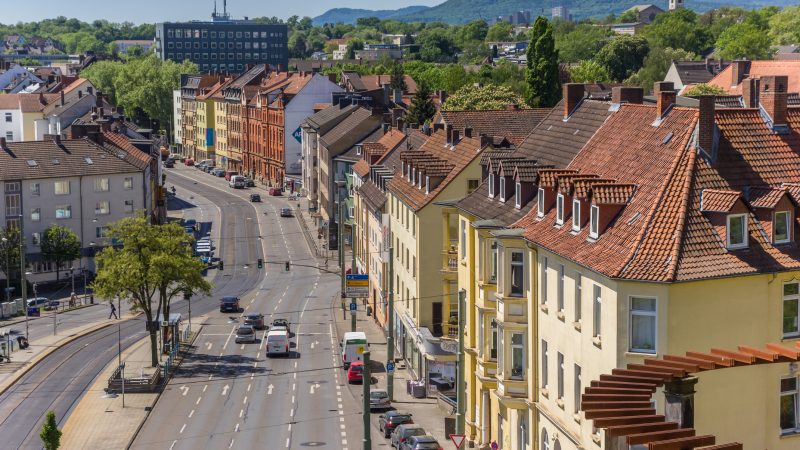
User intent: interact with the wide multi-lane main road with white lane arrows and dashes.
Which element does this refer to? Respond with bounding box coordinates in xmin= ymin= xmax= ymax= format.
xmin=133 ymin=167 xmax=362 ymax=449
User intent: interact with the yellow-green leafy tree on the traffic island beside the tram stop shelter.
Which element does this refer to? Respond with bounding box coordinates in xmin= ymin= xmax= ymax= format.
xmin=92 ymin=215 xmax=212 ymax=367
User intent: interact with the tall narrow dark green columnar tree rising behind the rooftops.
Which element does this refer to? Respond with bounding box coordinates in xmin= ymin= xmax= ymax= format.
xmin=525 ymin=16 xmax=561 ymax=108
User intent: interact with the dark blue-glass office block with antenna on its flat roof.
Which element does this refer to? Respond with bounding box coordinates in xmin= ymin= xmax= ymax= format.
xmin=155 ymin=4 xmax=289 ymax=73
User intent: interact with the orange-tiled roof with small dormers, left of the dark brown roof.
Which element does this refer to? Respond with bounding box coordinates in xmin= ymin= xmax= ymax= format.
xmin=387 ymin=130 xmax=482 ymax=211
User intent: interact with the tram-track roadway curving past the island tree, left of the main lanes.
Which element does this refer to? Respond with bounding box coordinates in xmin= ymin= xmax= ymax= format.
xmin=0 ymin=167 xmax=263 ymax=449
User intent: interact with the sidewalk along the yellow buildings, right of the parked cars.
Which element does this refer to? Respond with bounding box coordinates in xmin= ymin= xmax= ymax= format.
xmin=333 ymin=295 xmax=450 ymax=448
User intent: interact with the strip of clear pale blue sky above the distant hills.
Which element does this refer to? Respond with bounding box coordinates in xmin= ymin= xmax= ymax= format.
xmin=0 ymin=0 xmax=444 ymax=24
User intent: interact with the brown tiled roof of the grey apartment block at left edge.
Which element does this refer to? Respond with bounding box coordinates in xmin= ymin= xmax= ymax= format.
xmin=0 ymin=138 xmax=146 ymax=180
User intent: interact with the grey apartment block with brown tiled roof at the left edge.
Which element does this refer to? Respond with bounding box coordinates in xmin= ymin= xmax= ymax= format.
xmin=0 ymin=132 xmax=151 ymax=280
